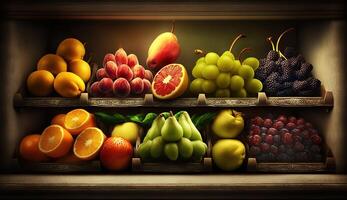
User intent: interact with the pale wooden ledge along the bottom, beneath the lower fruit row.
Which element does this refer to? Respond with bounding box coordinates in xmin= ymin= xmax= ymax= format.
xmin=0 ymin=174 xmax=347 ymax=199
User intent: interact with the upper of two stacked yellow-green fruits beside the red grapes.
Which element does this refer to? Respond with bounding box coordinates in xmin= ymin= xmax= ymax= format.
xmin=212 ymin=109 xmax=244 ymax=138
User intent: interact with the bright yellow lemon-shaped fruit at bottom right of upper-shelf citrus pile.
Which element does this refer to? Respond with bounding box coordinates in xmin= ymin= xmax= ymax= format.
xmin=54 ymin=72 xmax=85 ymax=97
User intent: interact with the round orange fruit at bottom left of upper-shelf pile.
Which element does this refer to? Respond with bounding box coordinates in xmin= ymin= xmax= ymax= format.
xmin=27 ymin=70 xmax=54 ymax=97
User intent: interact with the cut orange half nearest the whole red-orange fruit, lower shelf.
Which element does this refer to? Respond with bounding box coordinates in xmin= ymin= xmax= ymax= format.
xmin=73 ymin=127 xmax=106 ymax=160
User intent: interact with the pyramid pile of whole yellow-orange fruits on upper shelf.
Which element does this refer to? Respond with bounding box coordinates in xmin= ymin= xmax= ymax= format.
xmin=26 ymin=38 xmax=91 ymax=97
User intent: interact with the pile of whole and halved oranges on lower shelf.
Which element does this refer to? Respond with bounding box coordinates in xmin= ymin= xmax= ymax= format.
xmin=19 ymin=109 xmax=133 ymax=170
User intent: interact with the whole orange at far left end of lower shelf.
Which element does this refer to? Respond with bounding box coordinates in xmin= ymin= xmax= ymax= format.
xmin=19 ymin=134 xmax=48 ymax=162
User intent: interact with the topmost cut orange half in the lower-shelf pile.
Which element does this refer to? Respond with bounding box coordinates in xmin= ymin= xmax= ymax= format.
xmin=64 ymin=109 xmax=96 ymax=135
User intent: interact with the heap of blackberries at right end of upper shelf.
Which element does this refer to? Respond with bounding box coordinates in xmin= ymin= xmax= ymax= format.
xmin=255 ymin=47 xmax=321 ymax=96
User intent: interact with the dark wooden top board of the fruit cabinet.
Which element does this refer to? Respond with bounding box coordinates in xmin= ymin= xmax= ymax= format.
xmin=4 ymin=0 xmax=345 ymax=20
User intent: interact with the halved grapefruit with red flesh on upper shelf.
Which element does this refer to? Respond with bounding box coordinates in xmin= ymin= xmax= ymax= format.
xmin=152 ymin=63 xmax=189 ymax=99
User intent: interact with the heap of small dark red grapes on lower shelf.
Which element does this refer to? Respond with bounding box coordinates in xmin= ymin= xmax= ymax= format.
xmin=248 ymin=115 xmax=323 ymax=162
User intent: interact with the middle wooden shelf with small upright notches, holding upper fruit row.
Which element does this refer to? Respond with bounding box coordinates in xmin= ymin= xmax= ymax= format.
xmin=14 ymin=90 xmax=334 ymax=108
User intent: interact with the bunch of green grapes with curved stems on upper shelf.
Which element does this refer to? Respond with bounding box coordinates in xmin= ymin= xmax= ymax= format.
xmin=189 ymin=34 xmax=263 ymax=98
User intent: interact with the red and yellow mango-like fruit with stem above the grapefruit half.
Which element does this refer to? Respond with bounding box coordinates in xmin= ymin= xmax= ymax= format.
xmin=146 ymin=23 xmax=181 ymax=71
